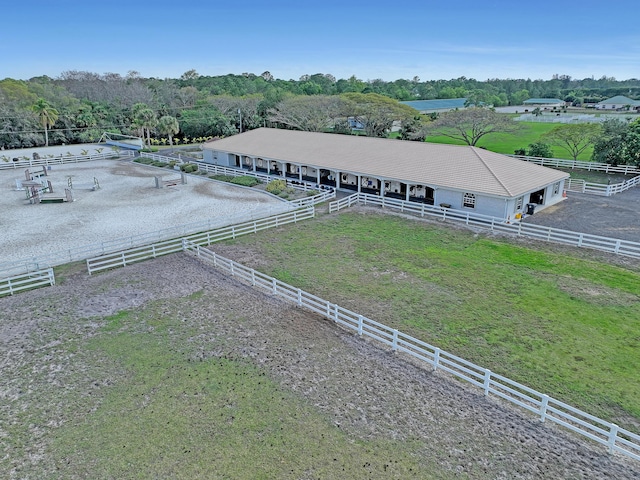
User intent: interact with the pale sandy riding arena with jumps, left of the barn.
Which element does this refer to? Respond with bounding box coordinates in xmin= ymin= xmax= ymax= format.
xmin=0 ymin=160 xmax=288 ymax=263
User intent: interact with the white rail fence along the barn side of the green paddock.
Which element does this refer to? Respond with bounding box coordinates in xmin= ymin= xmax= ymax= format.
xmin=329 ymin=193 xmax=640 ymax=258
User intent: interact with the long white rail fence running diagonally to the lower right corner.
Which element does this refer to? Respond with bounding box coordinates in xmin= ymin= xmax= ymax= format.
xmin=183 ymin=246 xmax=640 ymax=460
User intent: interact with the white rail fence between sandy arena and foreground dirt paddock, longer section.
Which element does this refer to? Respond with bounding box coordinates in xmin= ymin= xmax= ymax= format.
xmin=86 ymin=207 xmax=315 ymax=275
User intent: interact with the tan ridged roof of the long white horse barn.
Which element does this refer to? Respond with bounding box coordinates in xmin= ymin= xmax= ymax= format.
xmin=204 ymin=128 xmax=569 ymax=197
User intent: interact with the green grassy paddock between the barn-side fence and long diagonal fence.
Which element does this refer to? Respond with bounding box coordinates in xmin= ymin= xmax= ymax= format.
xmin=219 ymin=213 xmax=640 ymax=427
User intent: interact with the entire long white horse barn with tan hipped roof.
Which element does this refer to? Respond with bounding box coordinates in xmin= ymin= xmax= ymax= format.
xmin=203 ymin=128 xmax=569 ymax=220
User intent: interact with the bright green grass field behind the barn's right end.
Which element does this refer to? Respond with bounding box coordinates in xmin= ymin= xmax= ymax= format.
xmin=427 ymin=122 xmax=593 ymax=161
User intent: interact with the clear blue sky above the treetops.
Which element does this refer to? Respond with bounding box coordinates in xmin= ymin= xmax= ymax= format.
xmin=0 ymin=0 xmax=640 ymax=81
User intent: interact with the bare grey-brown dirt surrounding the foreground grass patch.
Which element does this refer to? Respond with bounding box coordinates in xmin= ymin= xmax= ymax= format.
xmin=0 ymin=254 xmax=640 ymax=479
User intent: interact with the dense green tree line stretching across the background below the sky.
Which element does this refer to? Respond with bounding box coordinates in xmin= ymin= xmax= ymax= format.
xmin=0 ymin=70 xmax=640 ymax=166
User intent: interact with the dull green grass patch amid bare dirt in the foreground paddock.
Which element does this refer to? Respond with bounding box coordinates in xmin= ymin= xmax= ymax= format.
xmin=51 ymin=294 xmax=440 ymax=479
